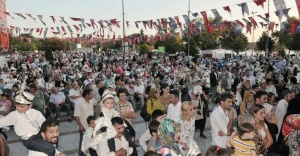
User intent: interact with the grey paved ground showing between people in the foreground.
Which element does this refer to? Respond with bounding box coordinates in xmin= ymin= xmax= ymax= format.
xmin=7 ymin=108 xmax=211 ymax=156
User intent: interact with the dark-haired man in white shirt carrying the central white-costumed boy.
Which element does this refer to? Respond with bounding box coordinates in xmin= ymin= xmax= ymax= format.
xmin=97 ymin=117 xmax=133 ymax=156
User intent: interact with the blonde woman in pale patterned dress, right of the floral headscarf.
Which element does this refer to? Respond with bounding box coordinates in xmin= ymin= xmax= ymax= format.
xmin=178 ymin=101 xmax=201 ymax=155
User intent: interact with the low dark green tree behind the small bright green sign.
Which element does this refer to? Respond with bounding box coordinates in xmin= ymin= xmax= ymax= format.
xmin=154 ymin=37 xmax=183 ymax=54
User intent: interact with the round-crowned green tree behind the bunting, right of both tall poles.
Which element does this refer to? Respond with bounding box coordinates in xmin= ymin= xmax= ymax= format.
xmin=219 ymin=29 xmax=248 ymax=54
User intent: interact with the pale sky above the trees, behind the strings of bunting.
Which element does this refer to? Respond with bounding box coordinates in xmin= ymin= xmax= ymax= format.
xmin=6 ymin=0 xmax=298 ymax=40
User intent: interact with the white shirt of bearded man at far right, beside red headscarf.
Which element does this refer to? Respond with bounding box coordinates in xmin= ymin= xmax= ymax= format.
xmin=275 ymin=99 xmax=288 ymax=136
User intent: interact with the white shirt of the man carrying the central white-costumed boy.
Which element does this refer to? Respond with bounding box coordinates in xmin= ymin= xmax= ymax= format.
xmin=96 ymin=136 xmax=132 ymax=156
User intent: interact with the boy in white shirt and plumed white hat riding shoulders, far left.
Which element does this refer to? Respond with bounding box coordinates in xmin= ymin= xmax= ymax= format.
xmin=0 ymin=91 xmax=56 ymax=156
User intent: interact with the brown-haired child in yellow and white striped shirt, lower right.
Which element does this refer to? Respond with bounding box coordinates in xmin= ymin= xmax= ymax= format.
xmin=227 ymin=123 xmax=257 ymax=156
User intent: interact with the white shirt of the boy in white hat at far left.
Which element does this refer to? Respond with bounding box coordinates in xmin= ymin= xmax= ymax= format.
xmin=0 ymin=109 xmax=46 ymax=140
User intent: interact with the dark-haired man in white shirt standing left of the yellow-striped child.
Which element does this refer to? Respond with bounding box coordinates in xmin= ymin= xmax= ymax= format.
xmin=210 ymin=93 xmax=234 ymax=148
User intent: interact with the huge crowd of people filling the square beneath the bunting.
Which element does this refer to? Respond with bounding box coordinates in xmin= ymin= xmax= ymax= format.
xmin=0 ymin=52 xmax=300 ymax=156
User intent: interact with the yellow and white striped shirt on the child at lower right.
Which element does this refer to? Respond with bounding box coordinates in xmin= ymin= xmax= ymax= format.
xmin=229 ymin=135 xmax=255 ymax=156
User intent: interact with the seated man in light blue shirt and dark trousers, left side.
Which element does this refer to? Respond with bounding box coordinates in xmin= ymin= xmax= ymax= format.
xmin=49 ymin=87 xmax=72 ymax=122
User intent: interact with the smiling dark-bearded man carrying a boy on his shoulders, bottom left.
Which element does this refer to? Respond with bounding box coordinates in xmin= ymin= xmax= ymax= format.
xmin=28 ymin=119 xmax=66 ymax=156
